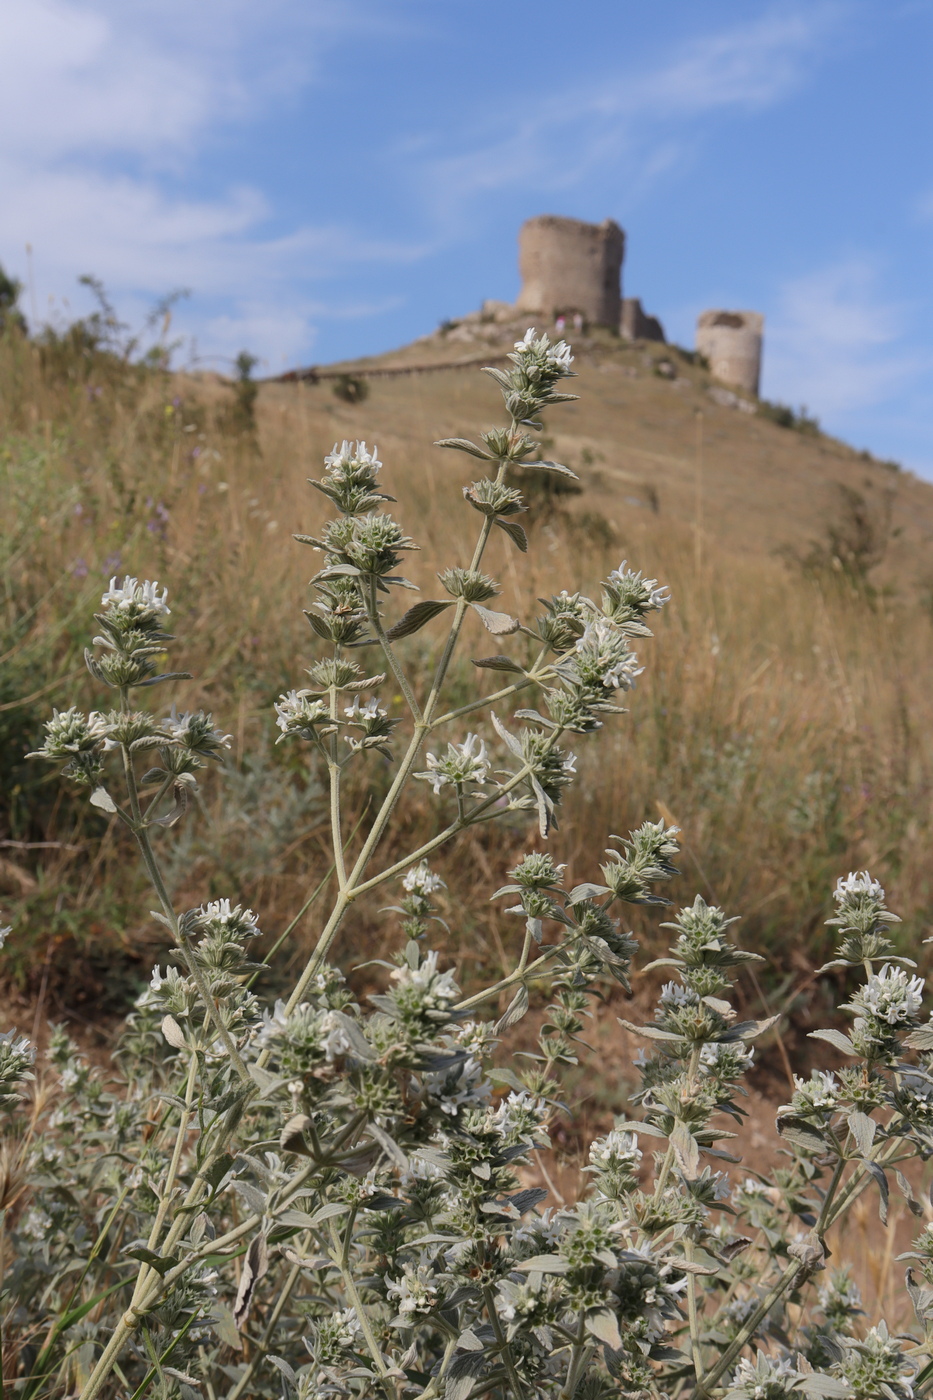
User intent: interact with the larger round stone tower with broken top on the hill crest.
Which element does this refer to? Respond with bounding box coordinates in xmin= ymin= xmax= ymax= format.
xmin=517 ymin=214 xmax=625 ymax=329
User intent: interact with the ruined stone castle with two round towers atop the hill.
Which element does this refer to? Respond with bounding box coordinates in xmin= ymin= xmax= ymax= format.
xmin=517 ymin=214 xmax=765 ymax=395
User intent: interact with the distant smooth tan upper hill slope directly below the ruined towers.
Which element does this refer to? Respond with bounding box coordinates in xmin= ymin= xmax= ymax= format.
xmin=261 ymin=308 xmax=933 ymax=587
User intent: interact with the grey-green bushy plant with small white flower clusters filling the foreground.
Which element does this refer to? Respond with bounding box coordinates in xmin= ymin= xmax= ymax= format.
xmin=0 ymin=332 xmax=933 ymax=1400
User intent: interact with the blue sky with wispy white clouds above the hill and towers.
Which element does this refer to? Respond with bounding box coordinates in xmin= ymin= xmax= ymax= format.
xmin=0 ymin=0 xmax=933 ymax=477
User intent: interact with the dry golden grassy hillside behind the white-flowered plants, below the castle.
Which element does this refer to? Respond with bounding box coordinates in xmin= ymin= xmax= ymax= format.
xmin=0 ymin=322 xmax=933 ymax=1036
